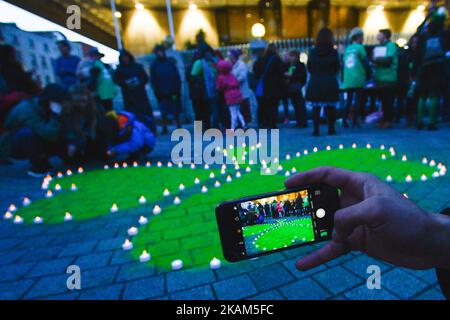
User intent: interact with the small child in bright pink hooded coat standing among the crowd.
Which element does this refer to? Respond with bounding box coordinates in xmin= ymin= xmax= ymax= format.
xmin=216 ymin=60 xmax=246 ymax=130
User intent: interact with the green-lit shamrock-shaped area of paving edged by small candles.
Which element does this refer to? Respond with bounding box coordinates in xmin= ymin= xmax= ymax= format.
xmin=11 ymin=148 xmax=437 ymax=269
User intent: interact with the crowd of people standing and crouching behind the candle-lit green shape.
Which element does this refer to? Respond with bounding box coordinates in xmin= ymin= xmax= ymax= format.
xmin=0 ymin=5 xmax=450 ymax=176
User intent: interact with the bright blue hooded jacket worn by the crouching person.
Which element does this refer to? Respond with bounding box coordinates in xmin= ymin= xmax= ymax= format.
xmin=111 ymin=111 xmax=156 ymax=154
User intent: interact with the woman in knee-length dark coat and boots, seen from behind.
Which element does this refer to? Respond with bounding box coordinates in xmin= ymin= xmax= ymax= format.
xmin=306 ymin=28 xmax=339 ymax=136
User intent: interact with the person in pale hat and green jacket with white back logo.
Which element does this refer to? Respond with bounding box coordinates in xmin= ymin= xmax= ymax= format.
xmin=341 ymin=28 xmax=370 ymax=128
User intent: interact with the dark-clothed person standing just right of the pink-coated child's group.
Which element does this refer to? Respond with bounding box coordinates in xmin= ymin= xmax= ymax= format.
xmin=253 ymin=43 xmax=284 ymax=129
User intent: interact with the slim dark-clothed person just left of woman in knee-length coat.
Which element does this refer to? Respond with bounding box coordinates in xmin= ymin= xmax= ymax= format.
xmin=285 ymin=50 xmax=308 ymax=128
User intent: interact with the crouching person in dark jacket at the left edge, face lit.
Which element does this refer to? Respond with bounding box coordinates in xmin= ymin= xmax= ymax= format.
xmin=0 ymin=84 xmax=71 ymax=178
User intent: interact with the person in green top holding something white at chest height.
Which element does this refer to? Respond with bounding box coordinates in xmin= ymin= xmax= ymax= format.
xmin=373 ymin=29 xmax=398 ymax=128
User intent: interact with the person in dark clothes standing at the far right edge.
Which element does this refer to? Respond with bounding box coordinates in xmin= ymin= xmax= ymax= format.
xmin=415 ymin=7 xmax=450 ymax=130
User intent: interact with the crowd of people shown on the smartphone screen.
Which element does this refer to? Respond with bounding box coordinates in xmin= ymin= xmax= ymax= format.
xmin=239 ymin=196 xmax=310 ymax=226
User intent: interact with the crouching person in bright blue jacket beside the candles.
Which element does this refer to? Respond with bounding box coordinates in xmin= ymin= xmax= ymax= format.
xmin=107 ymin=111 xmax=156 ymax=161
